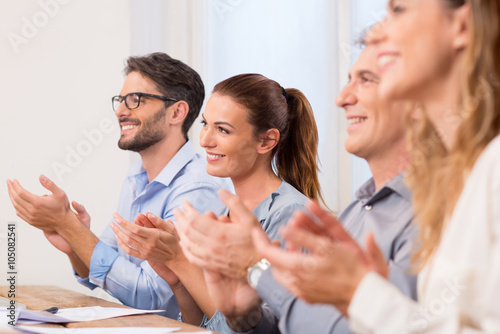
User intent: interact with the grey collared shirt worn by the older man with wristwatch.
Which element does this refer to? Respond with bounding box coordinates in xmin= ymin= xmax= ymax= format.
xmin=230 ymin=174 xmax=417 ymax=334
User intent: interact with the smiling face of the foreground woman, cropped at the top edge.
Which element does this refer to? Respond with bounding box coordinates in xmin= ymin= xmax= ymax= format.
xmin=374 ymin=0 xmax=462 ymax=100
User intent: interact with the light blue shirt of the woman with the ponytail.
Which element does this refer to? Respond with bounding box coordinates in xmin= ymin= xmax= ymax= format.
xmin=188 ymin=181 xmax=309 ymax=333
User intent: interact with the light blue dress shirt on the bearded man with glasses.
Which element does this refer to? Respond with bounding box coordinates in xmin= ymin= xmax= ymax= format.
xmin=78 ymin=141 xmax=230 ymax=318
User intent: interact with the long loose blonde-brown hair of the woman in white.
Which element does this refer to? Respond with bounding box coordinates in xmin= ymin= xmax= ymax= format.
xmin=407 ymin=0 xmax=500 ymax=267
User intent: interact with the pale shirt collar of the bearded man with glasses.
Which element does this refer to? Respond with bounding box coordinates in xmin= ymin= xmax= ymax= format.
xmin=128 ymin=140 xmax=196 ymax=186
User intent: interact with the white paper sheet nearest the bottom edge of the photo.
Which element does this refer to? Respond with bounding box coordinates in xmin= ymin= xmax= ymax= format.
xmin=16 ymin=326 xmax=212 ymax=334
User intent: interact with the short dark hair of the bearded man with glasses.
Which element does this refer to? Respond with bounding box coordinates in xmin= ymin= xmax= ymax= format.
xmin=124 ymin=52 xmax=205 ymax=139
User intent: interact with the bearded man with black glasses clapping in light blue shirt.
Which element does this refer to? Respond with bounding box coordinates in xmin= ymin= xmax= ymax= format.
xmin=8 ymin=53 xmax=224 ymax=318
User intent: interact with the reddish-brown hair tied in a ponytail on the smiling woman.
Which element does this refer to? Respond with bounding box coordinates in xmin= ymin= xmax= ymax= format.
xmin=213 ymin=74 xmax=324 ymax=202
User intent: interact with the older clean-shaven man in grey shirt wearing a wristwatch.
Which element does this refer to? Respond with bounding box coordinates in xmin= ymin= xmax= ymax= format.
xmin=174 ymin=46 xmax=417 ymax=333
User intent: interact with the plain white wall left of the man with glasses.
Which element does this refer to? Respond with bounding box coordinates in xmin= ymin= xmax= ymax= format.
xmin=0 ymin=0 xmax=130 ymax=298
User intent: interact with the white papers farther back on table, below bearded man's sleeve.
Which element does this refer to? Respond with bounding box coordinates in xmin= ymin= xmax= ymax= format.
xmin=16 ymin=306 xmax=164 ymax=324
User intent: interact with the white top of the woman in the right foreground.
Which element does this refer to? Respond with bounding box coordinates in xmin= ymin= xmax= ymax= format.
xmin=349 ymin=136 xmax=500 ymax=334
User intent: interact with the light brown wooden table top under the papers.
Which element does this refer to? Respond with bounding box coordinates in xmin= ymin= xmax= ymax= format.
xmin=0 ymin=285 xmax=213 ymax=333
